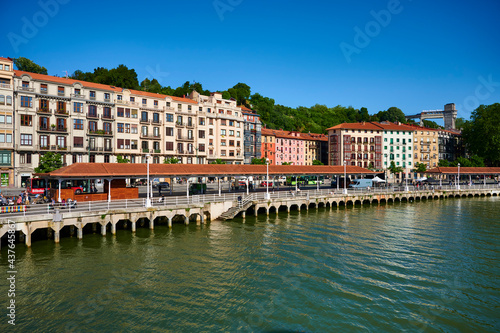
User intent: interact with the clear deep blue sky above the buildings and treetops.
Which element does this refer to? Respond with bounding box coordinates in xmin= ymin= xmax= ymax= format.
xmin=0 ymin=0 xmax=500 ymax=122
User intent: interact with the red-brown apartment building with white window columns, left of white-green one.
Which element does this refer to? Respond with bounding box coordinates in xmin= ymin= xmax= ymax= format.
xmin=327 ymin=122 xmax=382 ymax=169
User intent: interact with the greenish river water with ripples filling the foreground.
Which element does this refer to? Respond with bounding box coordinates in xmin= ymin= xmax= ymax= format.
xmin=0 ymin=197 xmax=500 ymax=332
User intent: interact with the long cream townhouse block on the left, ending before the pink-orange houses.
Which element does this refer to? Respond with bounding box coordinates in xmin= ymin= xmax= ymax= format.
xmin=0 ymin=58 xmax=268 ymax=186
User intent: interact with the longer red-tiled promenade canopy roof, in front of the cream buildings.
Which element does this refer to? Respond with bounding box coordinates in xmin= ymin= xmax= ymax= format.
xmin=47 ymin=163 xmax=374 ymax=178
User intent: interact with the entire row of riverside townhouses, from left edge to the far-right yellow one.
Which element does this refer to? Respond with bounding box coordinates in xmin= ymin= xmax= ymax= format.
xmin=0 ymin=57 xmax=461 ymax=186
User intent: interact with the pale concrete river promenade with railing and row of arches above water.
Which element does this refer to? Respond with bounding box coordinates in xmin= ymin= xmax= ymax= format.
xmin=0 ymin=185 xmax=500 ymax=247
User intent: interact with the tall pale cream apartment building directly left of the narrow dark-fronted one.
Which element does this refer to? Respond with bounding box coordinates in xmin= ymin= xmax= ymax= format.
xmin=189 ymin=91 xmax=245 ymax=164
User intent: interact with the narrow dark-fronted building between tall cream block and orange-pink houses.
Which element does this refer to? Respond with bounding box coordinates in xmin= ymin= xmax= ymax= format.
xmin=240 ymin=105 xmax=262 ymax=164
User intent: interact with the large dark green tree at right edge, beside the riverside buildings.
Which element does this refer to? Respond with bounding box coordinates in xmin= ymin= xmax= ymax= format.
xmin=462 ymin=103 xmax=500 ymax=166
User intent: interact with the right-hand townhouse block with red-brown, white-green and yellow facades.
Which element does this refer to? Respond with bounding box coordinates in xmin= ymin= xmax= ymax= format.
xmin=328 ymin=122 xmax=463 ymax=176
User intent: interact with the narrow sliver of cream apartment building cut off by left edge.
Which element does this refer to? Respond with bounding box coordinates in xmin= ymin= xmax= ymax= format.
xmin=0 ymin=57 xmax=14 ymax=186
